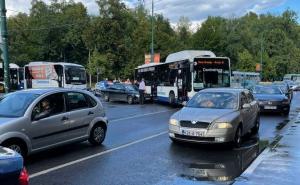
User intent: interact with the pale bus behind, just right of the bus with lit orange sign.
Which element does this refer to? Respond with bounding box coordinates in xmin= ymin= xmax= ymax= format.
xmin=231 ymin=71 xmax=261 ymax=88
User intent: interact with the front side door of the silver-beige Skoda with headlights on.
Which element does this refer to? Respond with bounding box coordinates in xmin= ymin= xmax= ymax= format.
xmin=240 ymin=92 xmax=252 ymax=133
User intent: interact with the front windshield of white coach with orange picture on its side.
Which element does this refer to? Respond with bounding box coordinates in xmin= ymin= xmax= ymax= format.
xmin=65 ymin=66 xmax=86 ymax=85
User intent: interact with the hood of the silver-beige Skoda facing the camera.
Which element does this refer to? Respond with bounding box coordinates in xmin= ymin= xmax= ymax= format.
xmin=174 ymin=107 xmax=236 ymax=123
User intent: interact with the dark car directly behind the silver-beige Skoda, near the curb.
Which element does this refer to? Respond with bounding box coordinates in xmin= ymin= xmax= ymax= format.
xmin=252 ymin=85 xmax=291 ymax=115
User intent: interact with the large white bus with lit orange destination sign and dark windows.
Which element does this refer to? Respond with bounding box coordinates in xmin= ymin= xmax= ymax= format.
xmin=135 ymin=50 xmax=230 ymax=104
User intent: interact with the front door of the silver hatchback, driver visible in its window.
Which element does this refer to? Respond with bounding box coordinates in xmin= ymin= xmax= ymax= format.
xmin=27 ymin=93 xmax=69 ymax=149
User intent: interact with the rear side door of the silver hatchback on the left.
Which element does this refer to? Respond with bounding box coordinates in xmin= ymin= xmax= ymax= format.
xmin=66 ymin=92 xmax=95 ymax=139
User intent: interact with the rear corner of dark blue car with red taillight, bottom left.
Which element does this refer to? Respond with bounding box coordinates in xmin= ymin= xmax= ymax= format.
xmin=0 ymin=146 xmax=29 ymax=185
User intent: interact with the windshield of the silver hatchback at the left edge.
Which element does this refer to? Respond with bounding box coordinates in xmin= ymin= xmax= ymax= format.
xmin=0 ymin=93 xmax=39 ymax=118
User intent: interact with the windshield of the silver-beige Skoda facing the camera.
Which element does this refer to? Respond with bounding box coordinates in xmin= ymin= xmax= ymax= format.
xmin=187 ymin=92 xmax=238 ymax=109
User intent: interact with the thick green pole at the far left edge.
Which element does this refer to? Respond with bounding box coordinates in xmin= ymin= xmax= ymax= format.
xmin=0 ymin=0 xmax=10 ymax=93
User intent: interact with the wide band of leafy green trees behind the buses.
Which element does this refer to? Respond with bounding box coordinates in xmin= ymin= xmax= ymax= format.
xmin=8 ymin=0 xmax=300 ymax=80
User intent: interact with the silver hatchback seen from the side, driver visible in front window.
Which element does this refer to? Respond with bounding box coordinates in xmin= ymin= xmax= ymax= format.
xmin=0 ymin=89 xmax=108 ymax=156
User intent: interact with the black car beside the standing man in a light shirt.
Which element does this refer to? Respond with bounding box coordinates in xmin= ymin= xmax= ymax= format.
xmin=102 ymin=83 xmax=139 ymax=104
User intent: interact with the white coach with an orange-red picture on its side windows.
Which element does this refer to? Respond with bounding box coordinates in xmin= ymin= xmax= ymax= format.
xmin=24 ymin=62 xmax=87 ymax=89
